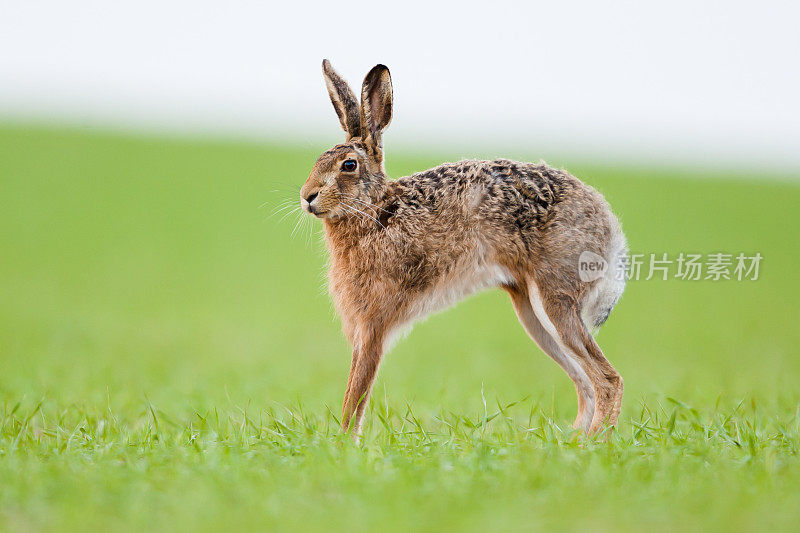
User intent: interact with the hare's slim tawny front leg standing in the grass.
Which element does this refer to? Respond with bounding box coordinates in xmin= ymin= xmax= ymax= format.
xmin=342 ymin=335 xmax=383 ymax=440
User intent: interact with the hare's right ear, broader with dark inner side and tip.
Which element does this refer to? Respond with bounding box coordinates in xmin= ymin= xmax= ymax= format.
xmin=361 ymin=65 xmax=392 ymax=163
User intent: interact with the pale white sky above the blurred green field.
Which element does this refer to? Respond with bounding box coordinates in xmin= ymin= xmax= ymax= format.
xmin=0 ymin=0 xmax=800 ymax=170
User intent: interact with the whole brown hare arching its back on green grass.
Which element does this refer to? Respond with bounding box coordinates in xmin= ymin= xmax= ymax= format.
xmin=300 ymin=60 xmax=627 ymax=438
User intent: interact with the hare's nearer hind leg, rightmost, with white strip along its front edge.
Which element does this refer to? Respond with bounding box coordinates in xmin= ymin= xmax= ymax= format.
xmin=530 ymin=282 xmax=623 ymax=433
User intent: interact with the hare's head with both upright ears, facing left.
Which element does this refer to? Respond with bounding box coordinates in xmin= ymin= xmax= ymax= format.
xmin=300 ymin=59 xmax=392 ymax=218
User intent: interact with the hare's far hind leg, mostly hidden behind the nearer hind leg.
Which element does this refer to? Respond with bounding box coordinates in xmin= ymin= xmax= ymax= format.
xmin=503 ymin=286 xmax=595 ymax=431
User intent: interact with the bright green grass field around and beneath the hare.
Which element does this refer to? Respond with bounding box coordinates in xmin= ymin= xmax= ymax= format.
xmin=0 ymin=126 xmax=800 ymax=531
